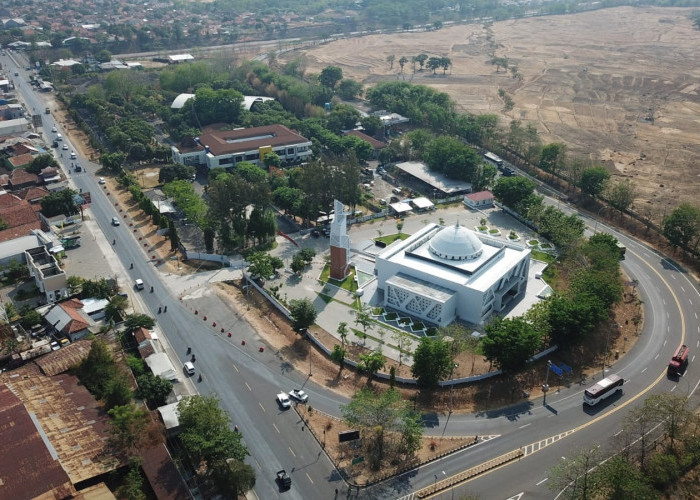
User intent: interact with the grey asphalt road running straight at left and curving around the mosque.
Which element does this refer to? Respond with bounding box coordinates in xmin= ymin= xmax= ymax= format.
xmin=3 ymin=49 xmax=700 ymax=499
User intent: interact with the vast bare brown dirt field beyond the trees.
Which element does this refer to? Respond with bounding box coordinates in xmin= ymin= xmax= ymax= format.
xmin=280 ymin=7 xmax=700 ymax=220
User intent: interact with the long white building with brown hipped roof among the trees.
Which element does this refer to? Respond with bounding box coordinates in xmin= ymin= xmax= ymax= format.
xmin=171 ymin=125 xmax=312 ymax=169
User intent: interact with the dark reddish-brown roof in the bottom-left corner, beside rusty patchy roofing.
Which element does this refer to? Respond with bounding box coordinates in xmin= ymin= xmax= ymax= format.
xmin=0 ymin=384 xmax=75 ymax=498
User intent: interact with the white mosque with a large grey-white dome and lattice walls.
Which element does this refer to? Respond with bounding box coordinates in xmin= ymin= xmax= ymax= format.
xmin=375 ymin=224 xmax=530 ymax=326
